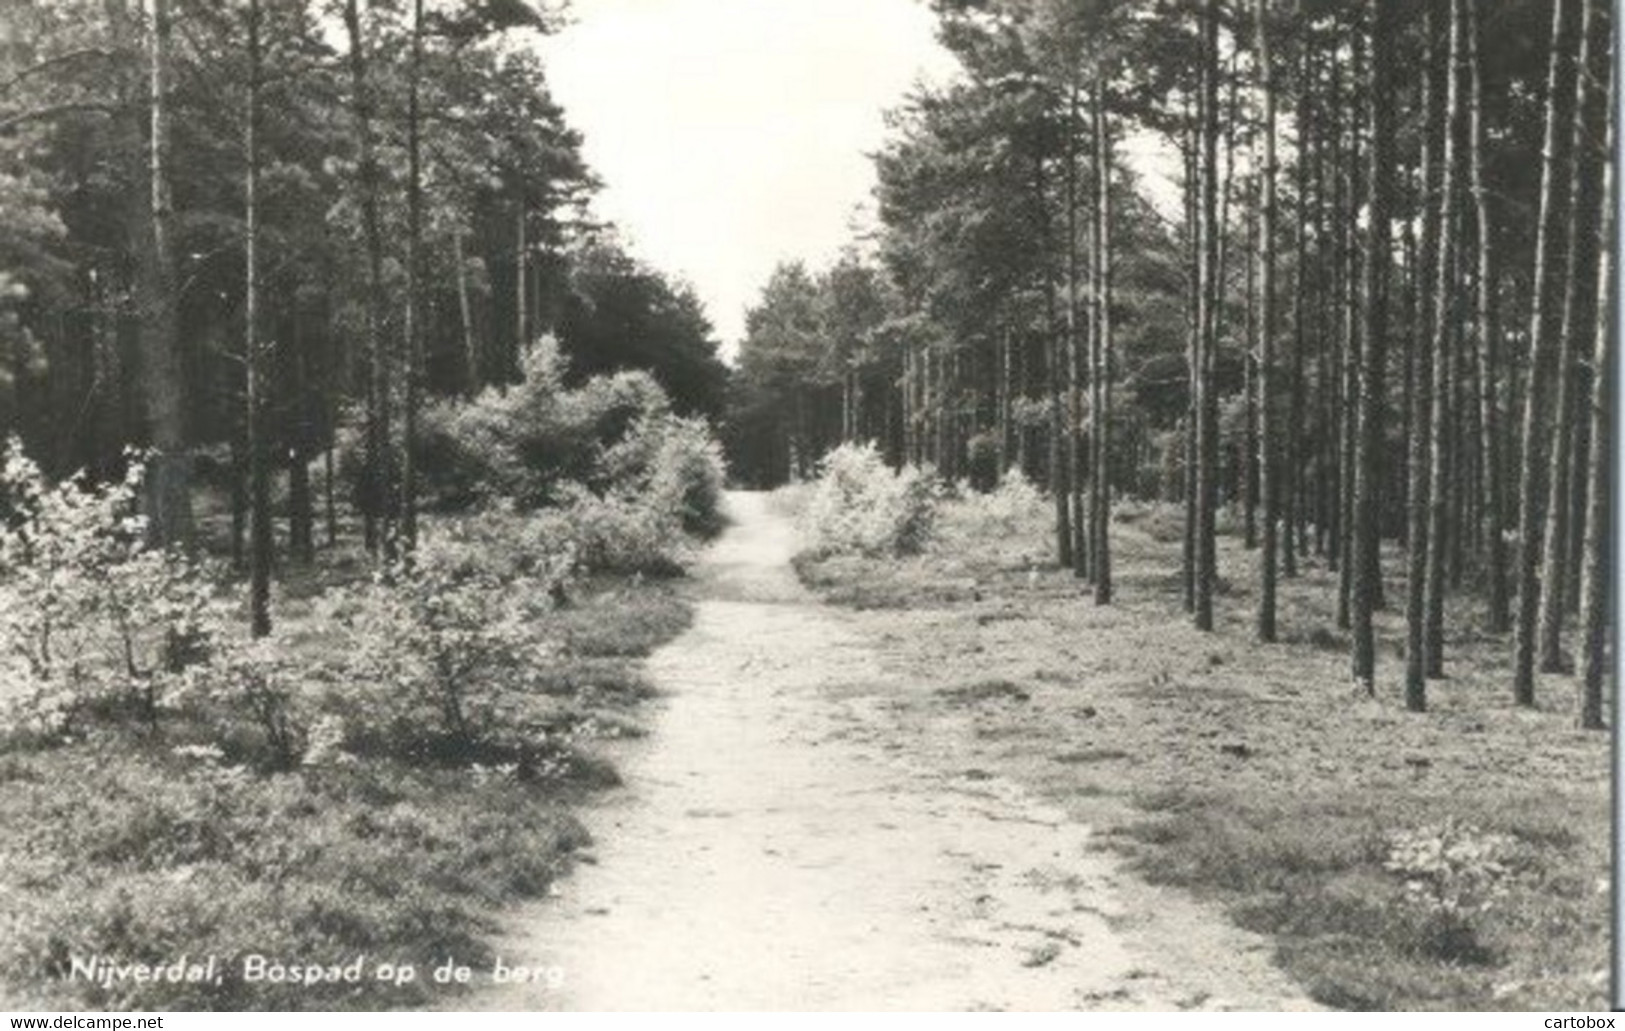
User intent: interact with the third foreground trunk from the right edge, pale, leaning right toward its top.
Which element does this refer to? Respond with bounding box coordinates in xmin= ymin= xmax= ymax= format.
xmin=1513 ymin=0 xmax=1575 ymax=706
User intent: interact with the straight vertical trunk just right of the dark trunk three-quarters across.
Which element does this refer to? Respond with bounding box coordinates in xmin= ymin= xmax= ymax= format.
xmin=1255 ymin=0 xmax=1281 ymax=644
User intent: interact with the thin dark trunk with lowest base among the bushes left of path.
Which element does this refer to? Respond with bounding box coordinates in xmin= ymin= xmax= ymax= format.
xmin=244 ymin=0 xmax=271 ymax=637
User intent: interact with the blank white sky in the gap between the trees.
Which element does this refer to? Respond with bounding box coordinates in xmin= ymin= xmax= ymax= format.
xmin=543 ymin=0 xmax=954 ymax=355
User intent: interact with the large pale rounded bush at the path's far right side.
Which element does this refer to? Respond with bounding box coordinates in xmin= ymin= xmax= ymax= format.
xmin=803 ymin=444 xmax=941 ymax=555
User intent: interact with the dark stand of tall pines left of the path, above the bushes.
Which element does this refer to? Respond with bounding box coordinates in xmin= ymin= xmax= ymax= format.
xmin=0 ymin=0 xmax=723 ymax=540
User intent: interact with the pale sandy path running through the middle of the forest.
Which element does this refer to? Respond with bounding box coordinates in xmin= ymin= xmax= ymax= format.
xmin=465 ymin=494 xmax=1308 ymax=1010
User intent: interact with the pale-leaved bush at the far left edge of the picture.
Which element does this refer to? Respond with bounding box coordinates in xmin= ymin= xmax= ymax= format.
xmin=0 ymin=441 xmax=213 ymax=733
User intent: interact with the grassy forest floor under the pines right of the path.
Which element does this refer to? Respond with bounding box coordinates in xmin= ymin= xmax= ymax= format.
xmin=798 ymin=491 xmax=1610 ymax=1010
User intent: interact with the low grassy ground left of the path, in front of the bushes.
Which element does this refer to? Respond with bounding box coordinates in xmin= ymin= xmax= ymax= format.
xmin=0 ymin=562 xmax=689 ymax=1010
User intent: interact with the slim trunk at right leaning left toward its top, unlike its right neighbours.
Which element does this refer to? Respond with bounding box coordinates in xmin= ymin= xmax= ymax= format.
xmin=1467 ymin=3 xmax=1511 ymax=634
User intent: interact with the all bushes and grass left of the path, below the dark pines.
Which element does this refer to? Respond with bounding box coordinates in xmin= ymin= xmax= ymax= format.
xmin=0 ymin=346 xmax=723 ymax=1008
